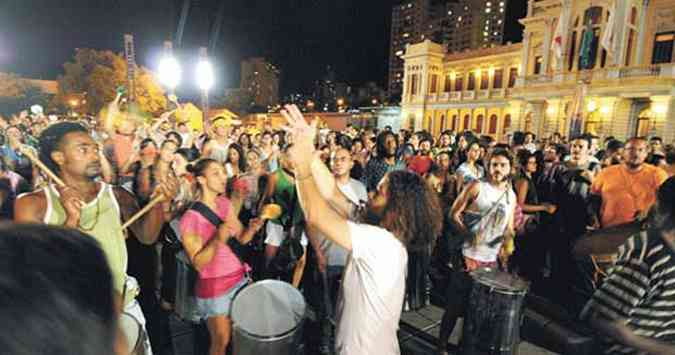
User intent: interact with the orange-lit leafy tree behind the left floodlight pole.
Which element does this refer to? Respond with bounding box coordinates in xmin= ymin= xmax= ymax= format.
xmin=52 ymin=49 xmax=167 ymax=114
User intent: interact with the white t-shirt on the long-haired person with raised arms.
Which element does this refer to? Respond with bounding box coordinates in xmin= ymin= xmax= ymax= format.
xmin=335 ymin=222 xmax=408 ymax=355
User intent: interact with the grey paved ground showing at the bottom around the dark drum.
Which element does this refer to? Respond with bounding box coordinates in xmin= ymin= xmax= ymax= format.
xmin=399 ymin=305 xmax=557 ymax=355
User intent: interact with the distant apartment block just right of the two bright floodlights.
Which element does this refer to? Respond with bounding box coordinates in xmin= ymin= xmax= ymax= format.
xmin=240 ymin=58 xmax=280 ymax=108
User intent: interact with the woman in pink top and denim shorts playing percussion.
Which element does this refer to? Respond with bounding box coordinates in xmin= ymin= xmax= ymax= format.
xmin=180 ymin=159 xmax=263 ymax=355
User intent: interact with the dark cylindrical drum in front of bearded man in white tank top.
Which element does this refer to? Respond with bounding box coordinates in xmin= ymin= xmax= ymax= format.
xmin=461 ymin=268 xmax=529 ymax=355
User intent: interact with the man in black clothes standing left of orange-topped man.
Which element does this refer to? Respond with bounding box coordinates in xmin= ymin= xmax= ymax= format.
xmin=542 ymin=134 xmax=600 ymax=314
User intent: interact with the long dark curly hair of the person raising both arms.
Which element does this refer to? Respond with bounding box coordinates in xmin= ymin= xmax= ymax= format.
xmin=382 ymin=170 xmax=443 ymax=252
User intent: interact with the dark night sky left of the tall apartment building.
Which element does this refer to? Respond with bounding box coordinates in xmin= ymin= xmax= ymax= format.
xmin=0 ymin=0 xmax=397 ymax=94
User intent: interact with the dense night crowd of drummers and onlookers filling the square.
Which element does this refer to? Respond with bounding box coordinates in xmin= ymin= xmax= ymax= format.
xmin=0 ymin=97 xmax=675 ymax=355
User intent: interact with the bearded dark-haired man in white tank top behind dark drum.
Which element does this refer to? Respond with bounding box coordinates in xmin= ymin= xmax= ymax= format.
xmin=438 ymin=149 xmax=517 ymax=354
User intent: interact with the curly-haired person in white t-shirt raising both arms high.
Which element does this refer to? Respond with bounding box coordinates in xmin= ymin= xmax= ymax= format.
xmin=282 ymin=105 xmax=442 ymax=355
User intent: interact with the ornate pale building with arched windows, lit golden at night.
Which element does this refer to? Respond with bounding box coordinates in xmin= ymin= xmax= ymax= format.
xmin=402 ymin=0 xmax=675 ymax=142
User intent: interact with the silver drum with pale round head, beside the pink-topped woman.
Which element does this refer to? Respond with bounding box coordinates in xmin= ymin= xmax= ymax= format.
xmin=230 ymin=280 xmax=306 ymax=355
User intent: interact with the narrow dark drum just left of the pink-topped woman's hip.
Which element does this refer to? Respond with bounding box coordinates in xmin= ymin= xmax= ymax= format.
xmin=174 ymin=251 xmax=199 ymax=322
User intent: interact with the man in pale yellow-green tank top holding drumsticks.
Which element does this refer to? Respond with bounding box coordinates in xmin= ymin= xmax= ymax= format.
xmin=14 ymin=122 xmax=177 ymax=350
